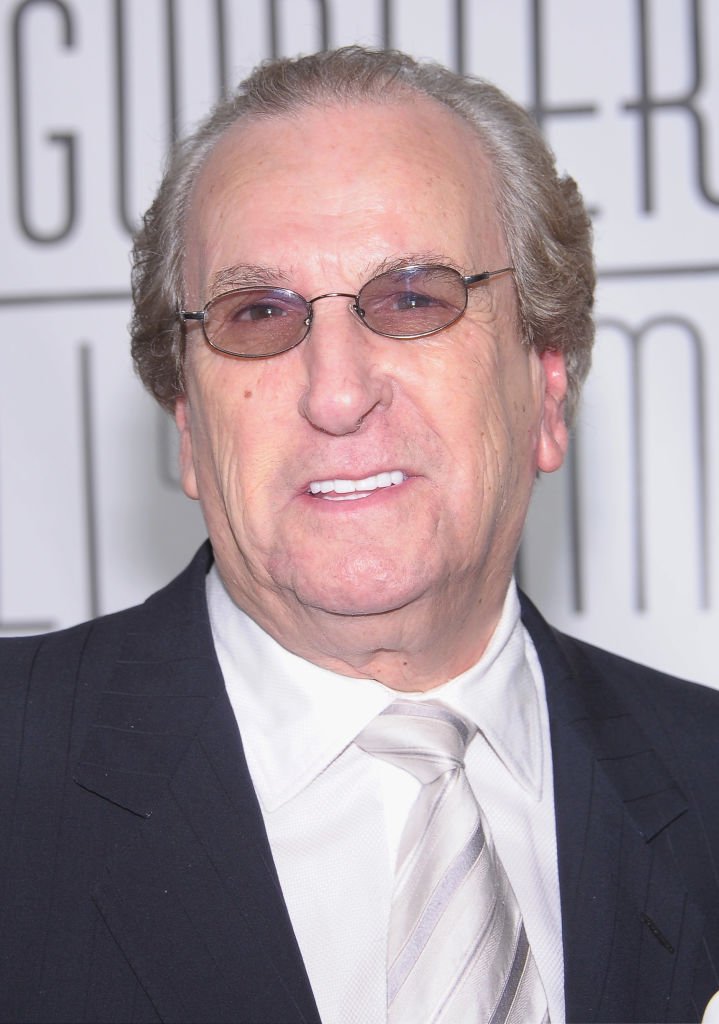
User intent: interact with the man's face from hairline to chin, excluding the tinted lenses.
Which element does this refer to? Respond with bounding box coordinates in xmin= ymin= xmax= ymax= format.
xmin=177 ymin=97 xmax=565 ymax=655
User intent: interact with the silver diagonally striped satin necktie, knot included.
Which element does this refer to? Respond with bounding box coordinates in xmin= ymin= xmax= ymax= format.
xmin=355 ymin=700 xmax=549 ymax=1024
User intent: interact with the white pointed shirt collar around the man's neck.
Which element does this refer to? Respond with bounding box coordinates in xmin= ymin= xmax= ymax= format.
xmin=207 ymin=566 xmax=543 ymax=812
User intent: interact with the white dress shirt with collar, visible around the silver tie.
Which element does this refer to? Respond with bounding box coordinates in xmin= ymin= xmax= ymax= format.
xmin=207 ymin=567 xmax=564 ymax=1024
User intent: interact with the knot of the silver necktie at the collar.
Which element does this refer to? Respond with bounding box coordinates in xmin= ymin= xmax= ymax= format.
xmin=355 ymin=700 xmax=476 ymax=783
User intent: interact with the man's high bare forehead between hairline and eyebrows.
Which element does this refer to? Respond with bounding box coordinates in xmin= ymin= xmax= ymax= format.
xmin=185 ymin=94 xmax=506 ymax=296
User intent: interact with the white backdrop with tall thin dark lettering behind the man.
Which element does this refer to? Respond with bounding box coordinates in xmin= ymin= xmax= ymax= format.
xmin=0 ymin=0 xmax=719 ymax=686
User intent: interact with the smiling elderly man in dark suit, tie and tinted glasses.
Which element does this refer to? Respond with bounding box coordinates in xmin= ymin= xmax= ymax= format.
xmin=0 ymin=48 xmax=719 ymax=1024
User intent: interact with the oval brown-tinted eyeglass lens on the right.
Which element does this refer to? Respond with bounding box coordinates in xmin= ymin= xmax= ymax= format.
xmin=357 ymin=266 xmax=467 ymax=338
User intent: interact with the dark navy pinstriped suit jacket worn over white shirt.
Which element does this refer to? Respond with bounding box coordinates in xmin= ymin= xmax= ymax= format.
xmin=0 ymin=547 xmax=719 ymax=1024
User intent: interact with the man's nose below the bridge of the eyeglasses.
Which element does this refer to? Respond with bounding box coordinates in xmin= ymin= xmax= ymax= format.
xmin=299 ymin=296 xmax=392 ymax=436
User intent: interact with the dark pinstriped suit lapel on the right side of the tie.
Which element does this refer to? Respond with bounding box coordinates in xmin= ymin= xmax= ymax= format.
xmin=523 ymin=602 xmax=703 ymax=1022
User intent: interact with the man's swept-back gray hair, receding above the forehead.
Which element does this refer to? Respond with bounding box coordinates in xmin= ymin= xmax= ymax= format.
xmin=131 ymin=46 xmax=594 ymax=419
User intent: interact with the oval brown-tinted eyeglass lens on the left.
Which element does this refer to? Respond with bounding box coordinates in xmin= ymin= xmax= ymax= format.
xmin=205 ymin=288 xmax=310 ymax=357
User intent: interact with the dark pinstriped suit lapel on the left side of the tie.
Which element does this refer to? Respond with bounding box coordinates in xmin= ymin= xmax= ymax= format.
xmin=75 ymin=551 xmax=319 ymax=1022
